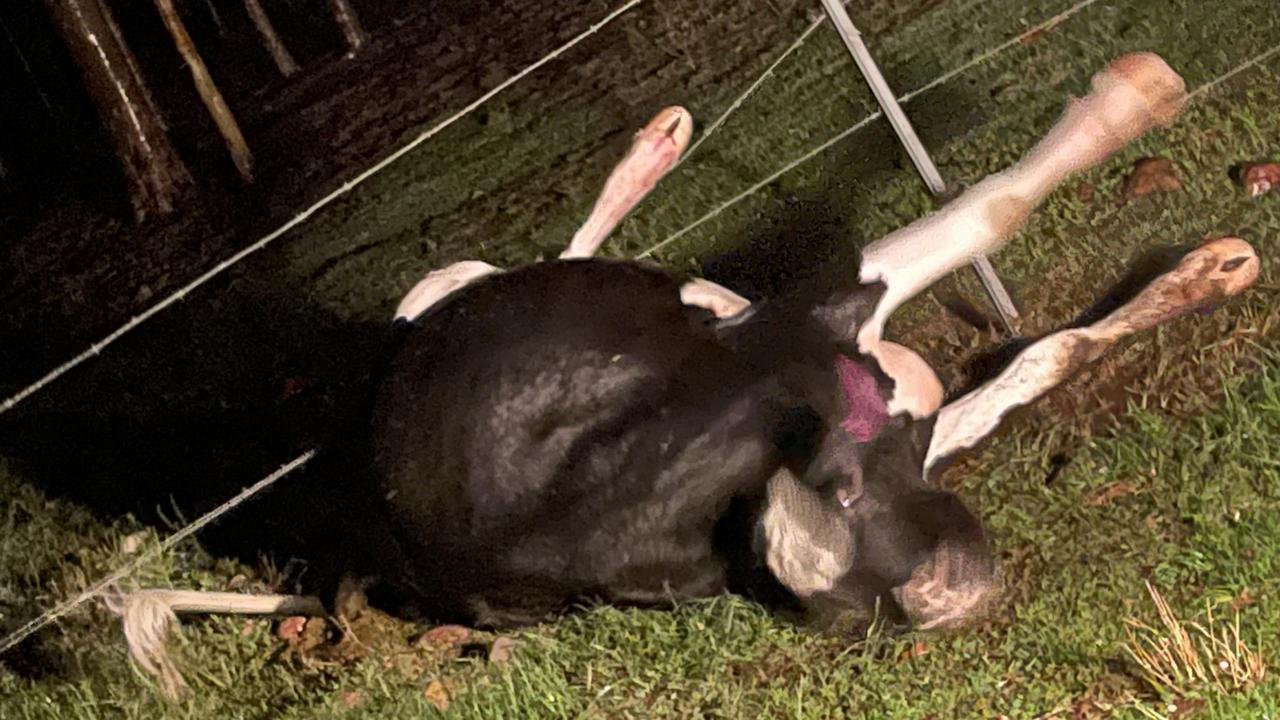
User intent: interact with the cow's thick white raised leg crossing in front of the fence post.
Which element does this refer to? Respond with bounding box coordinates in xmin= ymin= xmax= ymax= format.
xmin=858 ymin=53 xmax=1185 ymax=355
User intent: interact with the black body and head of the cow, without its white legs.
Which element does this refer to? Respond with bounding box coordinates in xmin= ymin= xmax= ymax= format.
xmin=375 ymin=254 xmax=992 ymax=625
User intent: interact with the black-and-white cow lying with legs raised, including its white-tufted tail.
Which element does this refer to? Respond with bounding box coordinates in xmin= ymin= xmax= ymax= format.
xmin=102 ymin=54 xmax=1258 ymax=696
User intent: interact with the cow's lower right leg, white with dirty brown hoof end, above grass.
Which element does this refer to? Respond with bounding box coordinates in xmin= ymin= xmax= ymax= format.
xmin=924 ymin=237 xmax=1258 ymax=477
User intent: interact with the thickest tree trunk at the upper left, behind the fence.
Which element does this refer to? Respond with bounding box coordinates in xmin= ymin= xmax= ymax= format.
xmin=45 ymin=0 xmax=191 ymax=222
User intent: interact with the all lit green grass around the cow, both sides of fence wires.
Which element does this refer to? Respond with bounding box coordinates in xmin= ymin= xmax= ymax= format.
xmin=0 ymin=0 xmax=1280 ymax=719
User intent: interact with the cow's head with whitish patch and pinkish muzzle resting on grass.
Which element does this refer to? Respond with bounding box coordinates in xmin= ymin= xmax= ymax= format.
xmin=759 ymin=415 xmax=996 ymax=628
